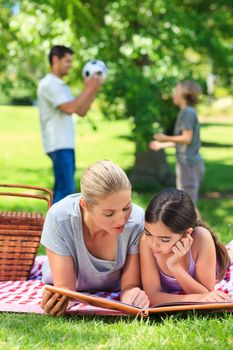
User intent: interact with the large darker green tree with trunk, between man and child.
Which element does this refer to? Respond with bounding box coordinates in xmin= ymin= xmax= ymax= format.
xmin=2 ymin=0 xmax=233 ymax=189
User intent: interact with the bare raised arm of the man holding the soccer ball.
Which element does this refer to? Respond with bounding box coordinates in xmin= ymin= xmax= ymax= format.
xmin=59 ymin=76 xmax=101 ymax=117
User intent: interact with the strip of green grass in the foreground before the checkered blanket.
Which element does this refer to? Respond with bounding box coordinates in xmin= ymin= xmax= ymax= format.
xmin=0 ymin=313 xmax=233 ymax=350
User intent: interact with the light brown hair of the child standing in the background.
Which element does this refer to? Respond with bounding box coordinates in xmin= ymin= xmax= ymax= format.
xmin=177 ymin=80 xmax=201 ymax=106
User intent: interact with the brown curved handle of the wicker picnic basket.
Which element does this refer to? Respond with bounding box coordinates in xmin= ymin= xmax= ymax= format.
xmin=0 ymin=184 xmax=53 ymax=208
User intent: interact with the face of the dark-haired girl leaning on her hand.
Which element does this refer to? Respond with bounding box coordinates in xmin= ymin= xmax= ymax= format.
xmin=144 ymin=221 xmax=184 ymax=257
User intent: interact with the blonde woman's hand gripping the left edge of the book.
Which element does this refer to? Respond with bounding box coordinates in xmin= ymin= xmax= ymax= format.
xmin=40 ymin=289 xmax=68 ymax=316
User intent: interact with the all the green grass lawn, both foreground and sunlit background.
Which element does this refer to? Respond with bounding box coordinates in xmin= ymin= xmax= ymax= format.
xmin=0 ymin=107 xmax=233 ymax=349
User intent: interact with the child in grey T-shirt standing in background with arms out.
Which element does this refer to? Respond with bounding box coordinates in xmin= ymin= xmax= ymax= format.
xmin=149 ymin=80 xmax=205 ymax=203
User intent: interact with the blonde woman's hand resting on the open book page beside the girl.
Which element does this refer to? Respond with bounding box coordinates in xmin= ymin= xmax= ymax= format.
xmin=121 ymin=287 xmax=150 ymax=309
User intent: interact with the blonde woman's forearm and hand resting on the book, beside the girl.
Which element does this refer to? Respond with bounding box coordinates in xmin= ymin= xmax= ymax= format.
xmin=121 ymin=254 xmax=149 ymax=308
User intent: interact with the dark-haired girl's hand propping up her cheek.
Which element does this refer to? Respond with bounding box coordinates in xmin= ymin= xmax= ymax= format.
xmin=167 ymin=235 xmax=193 ymax=272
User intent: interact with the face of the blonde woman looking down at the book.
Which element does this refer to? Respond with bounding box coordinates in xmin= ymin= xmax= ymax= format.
xmin=83 ymin=190 xmax=132 ymax=234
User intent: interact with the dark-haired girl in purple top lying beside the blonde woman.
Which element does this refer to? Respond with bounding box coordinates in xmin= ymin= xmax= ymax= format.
xmin=140 ymin=189 xmax=231 ymax=305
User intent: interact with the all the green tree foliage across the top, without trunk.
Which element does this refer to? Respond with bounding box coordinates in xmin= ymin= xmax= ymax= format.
xmin=1 ymin=0 xmax=233 ymax=151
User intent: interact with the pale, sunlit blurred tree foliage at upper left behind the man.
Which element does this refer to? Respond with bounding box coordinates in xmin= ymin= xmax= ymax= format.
xmin=0 ymin=0 xmax=73 ymax=103
